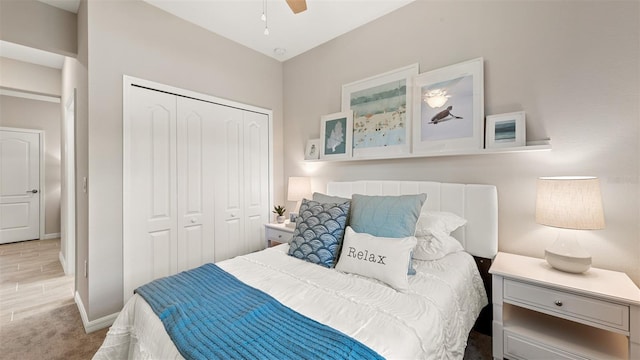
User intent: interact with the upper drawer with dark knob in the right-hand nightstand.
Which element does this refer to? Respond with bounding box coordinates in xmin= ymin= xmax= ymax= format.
xmin=504 ymin=279 xmax=629 ymax=332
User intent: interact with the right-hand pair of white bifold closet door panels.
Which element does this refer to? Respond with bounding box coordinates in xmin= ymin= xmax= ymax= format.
xmin=215 ymin=106 xmax=269 ymax=261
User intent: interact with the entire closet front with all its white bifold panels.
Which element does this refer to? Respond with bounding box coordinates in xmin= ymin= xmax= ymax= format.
xmin=123 ymin=78 xmax=270 ymax=301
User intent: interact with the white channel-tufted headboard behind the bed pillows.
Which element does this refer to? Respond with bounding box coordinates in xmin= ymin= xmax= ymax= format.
xmin=327 ymin=180 xmax=498 ymax=259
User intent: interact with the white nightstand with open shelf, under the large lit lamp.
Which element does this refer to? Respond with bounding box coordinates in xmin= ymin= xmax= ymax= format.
xmin=489 ymin=252 xmax=640 ymax=360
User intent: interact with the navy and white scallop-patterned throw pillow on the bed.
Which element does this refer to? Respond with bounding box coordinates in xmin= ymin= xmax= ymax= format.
xmin=289 ymin=199 xmax=351 ymax=268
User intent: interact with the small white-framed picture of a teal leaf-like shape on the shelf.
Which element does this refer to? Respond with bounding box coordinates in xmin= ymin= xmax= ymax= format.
xmin=320 ymin=111 xmax=353 ymax=159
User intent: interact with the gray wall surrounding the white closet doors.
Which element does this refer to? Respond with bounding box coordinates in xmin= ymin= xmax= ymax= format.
xmin=84 ymin=1 xmax=283 ymax=320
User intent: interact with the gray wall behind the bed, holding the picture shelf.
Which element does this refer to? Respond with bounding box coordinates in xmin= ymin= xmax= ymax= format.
xmin=284 ymin=1 xmax=640 ymax=284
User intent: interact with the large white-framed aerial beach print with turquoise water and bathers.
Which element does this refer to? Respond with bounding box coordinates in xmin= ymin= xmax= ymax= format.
xmin=342 ymin=63 xmax=419 ymax=158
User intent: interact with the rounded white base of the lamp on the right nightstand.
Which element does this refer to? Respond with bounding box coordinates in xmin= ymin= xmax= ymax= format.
xmin=544 ymin=237 xmax=591 ymax=274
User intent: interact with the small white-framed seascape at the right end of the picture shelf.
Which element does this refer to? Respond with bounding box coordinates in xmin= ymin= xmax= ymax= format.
xmin=485 ymin=111 xmax=527 ymax=149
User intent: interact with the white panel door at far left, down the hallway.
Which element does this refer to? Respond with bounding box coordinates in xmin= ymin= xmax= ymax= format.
xmin=0 ymin=130 xmax=40 ymax=244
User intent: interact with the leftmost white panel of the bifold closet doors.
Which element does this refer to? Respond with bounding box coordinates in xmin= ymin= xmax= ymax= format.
xmin=123 ymin=86 xmax=178 ymax=301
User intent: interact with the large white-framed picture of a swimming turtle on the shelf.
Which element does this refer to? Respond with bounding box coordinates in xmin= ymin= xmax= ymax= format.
xmin=412 ymin=58 xmax=484 ymax=154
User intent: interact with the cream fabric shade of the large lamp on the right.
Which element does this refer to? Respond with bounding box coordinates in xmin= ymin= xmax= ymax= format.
xmin=536 ymin=176 xmax=605 ymax=230
